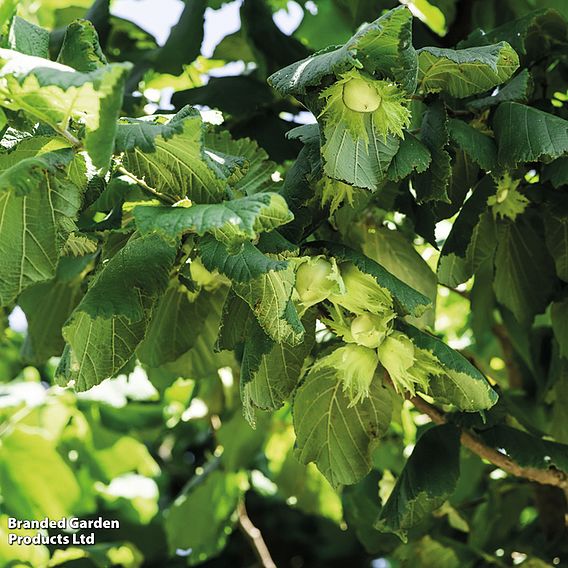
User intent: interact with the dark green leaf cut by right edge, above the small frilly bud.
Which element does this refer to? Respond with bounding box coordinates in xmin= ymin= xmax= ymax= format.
xmin=493 ymin=103 xmax=568 ymax=166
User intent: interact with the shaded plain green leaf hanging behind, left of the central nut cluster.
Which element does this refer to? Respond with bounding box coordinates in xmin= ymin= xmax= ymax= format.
xmin=136 ymin=280 xmax=209 ymax=367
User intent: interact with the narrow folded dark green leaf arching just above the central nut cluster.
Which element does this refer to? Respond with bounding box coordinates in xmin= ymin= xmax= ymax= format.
xmin=323 ymin=243 xmax=431 ymax=316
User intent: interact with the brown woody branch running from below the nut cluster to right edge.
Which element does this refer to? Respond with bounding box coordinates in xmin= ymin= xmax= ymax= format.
xmin=408 ymin=396 xmax=568 ymax=489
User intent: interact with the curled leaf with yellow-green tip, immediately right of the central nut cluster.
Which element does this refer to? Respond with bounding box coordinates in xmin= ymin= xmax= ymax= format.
xmin=398 ymin=322 xmax=497 ymax=412
